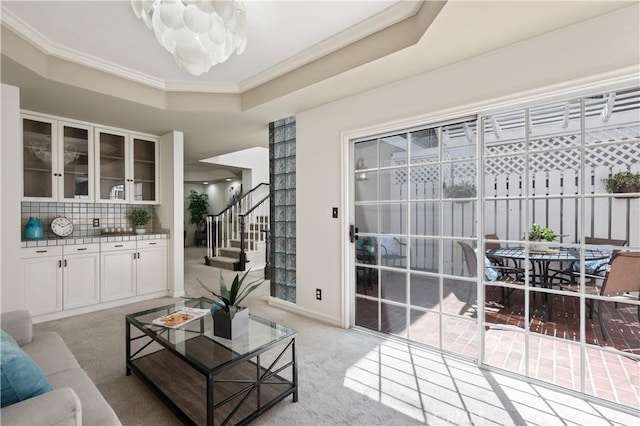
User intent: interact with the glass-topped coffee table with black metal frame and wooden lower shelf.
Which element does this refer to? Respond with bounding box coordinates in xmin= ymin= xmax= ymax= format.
xmin=126 ymin=298 xmax=298 ymax=426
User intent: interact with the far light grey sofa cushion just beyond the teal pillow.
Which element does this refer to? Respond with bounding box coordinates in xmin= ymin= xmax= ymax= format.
xmin=22 ymin=332 xmax=80 ymax=376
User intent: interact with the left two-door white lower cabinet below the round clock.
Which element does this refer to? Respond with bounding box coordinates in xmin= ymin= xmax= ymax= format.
xmin=21 ymin=244 xmax=100 ymax=316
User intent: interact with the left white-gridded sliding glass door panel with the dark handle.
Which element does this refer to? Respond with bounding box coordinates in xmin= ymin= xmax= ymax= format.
xmin=351 ymin=118 xmax=478 ymax=357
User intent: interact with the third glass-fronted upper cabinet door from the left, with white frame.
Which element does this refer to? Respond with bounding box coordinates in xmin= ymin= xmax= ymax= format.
xmin=95 ymin=129 xmax=129 ymax=202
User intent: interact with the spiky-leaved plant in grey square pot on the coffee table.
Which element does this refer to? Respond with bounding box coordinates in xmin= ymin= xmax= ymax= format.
xmin=198 ymin=271 xmax=265 ymax=340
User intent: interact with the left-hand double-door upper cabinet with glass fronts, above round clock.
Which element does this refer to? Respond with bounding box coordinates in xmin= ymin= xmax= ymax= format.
xmin=21 ymin=114 xmax=94 ymax=202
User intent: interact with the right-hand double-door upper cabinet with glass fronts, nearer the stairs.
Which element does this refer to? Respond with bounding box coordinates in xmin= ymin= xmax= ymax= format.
xmin=95 ymin=128 xmax=158 ymax=204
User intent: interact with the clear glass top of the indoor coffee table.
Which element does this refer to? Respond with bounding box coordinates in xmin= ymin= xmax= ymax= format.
xmin=127 ymin=298 xmax=296 ymax=372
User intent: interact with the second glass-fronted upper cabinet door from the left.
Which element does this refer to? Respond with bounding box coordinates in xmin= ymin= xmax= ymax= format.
xmin=58 ymin=122 xmax=94 ymax=202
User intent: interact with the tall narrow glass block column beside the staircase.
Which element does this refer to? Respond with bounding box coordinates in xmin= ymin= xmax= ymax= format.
xmin=269 ymin=117 xmax=296 ymax=303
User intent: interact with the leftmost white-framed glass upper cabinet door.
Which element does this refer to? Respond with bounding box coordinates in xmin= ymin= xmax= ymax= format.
xmin=22 ymin=114 xmax=58 ymax=200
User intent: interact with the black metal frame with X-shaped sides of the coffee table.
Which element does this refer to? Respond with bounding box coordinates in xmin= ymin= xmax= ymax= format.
xmin=125 ymin=305 xmax=298 ymax=426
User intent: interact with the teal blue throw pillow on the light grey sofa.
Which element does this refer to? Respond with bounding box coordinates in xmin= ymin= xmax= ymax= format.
xmin=0 ymin=330 xmax=52 ymax=407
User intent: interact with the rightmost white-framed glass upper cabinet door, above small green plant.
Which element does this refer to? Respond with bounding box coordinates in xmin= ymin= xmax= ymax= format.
xmin=131 ymin=135 xmax=158 ymax=203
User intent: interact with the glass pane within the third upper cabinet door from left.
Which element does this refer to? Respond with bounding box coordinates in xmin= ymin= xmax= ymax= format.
xmin=98 ymin=132 xmax=127 ymax=201
